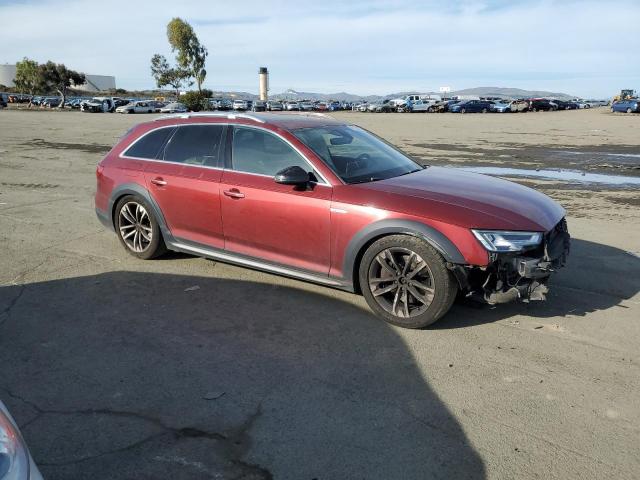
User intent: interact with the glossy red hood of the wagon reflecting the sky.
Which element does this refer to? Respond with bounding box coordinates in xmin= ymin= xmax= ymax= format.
xmin=357 ymin=167 xmax=566 ymax=231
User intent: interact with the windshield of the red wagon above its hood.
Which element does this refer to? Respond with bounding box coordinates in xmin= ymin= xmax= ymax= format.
xmin=293 ymin=125 xmax=424 ymax=183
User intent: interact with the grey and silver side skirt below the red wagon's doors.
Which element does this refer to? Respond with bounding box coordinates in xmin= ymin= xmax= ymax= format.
xmin=165 ymin=237 xmax=354 ymax=292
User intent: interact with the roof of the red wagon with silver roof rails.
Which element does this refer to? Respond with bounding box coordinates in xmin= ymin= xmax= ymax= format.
xmin=155 ymin=112 xmax=346 ymax=130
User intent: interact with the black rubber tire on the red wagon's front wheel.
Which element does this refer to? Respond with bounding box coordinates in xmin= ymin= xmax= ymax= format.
xmin=358 ymin=235 xmax=458 ymax=328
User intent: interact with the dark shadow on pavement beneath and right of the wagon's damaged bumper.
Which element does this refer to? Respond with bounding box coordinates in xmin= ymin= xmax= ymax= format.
xmin=440 ymin=239 xmax=640 ymax=329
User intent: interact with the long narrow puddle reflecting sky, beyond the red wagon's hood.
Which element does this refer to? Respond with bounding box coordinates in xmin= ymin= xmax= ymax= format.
xmin=454 ymin=167 xmax=640 ymax=186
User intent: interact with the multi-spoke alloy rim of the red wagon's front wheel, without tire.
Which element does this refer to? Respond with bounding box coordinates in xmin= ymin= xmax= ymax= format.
xmin=368 ymin=247 xmax=435 ymax=318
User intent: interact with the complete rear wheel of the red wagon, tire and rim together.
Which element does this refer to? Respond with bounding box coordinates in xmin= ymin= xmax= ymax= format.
xmin=115 ymin=195 xmax=166 ymax=260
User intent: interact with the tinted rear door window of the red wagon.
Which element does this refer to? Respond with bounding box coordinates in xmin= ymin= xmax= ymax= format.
xmin=162 ymin=125 xmax=224 ymax=167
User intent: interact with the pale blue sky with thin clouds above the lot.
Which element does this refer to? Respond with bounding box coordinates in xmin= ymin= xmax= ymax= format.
xmin=0 ymin=0 xmax=640 ymax=98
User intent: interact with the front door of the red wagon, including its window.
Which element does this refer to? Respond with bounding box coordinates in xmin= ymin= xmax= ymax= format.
xmin=220 ymin=126 xmax=333 ymax=275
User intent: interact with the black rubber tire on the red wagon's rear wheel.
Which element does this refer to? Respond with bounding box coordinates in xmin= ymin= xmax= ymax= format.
xmin=114 ymin=195 xmax=167 ymax=260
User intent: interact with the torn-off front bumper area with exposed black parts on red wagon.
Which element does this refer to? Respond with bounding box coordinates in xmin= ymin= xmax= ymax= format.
xmin=454 ymin=219 xmax=571 ymax=304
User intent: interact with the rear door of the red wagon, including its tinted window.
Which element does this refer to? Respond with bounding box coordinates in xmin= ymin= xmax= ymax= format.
xmin=145 ymin=123 xmax=226 ymax=248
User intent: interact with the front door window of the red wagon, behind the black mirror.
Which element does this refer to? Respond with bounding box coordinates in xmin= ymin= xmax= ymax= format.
xmin=231 ymin=127 xmax=317 ymax=178
